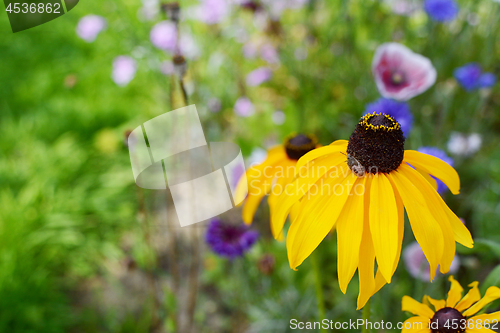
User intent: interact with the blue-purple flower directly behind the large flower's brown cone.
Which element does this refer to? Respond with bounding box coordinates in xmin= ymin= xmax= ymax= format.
xmin=364 ymin=97 xmax=413 ymax=137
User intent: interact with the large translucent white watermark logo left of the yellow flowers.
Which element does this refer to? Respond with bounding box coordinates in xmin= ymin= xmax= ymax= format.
xmin=128 ymin=105 xmax=248 ymax=227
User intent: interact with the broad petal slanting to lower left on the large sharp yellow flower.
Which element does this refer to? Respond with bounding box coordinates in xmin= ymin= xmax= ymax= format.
xmin=286 ymin=166 xmax=354 ymax=269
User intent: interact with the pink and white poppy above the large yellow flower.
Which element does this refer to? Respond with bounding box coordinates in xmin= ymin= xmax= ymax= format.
xmin=372 ymin=43 xmax=437 ymax=101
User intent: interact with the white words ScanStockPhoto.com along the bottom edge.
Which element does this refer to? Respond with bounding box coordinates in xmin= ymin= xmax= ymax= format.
xmin=290 ymin=319 xmax=424 ymax=331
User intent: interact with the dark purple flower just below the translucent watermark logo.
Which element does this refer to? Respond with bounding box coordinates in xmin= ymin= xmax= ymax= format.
xmin=205 ymin=218 xmax=259 ymax=259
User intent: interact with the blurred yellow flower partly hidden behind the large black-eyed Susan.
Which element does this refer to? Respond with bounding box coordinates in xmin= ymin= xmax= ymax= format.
xmin=236 ymin=134 xmax=318 ymax=238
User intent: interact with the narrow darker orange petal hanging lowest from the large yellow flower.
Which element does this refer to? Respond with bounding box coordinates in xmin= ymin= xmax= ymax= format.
xmin=357 ymin=177 xmax=375 ymax=310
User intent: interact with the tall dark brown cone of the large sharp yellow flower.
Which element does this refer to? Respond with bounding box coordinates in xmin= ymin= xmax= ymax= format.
xmin=347 ymin=113 xmax=405 ymax=175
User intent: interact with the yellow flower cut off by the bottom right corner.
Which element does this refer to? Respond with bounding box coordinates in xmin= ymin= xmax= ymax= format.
xmin=402 ymin=276 xmax=500 ymax=333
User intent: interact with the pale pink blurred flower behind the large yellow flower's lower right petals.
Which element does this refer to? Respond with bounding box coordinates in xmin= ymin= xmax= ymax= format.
xmin=403 ymin=242 xmax=460 ymax=282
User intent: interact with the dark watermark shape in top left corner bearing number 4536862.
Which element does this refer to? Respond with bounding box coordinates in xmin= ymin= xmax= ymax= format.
xmin=3 ymin=0 xmax=79 ymax=33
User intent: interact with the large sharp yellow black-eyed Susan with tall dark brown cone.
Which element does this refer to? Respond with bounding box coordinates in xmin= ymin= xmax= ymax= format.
xmin=271 ymin=113 xmax=473 ymax=308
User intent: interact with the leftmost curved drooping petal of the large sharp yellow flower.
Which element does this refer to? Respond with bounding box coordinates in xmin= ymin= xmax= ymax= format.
xmin=271 ymin=153 xmax=347 ymax=237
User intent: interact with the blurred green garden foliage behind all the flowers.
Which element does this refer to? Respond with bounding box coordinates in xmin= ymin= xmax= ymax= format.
xmin=0 ymin=0 xmax=500 ymax=333
